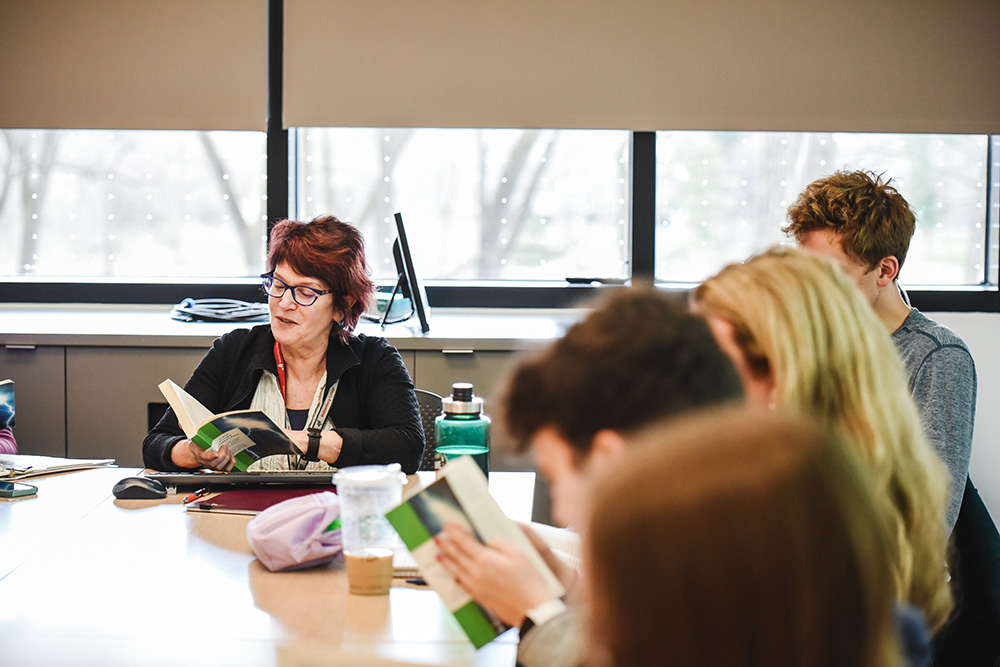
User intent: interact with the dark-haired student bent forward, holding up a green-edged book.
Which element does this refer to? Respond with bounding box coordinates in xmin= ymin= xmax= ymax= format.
xmin=439 ymin=287 xmax=741 ymax=667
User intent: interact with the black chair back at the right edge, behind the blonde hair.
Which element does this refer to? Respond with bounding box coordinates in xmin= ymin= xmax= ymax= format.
xmin=933 ymin=478 xmax=1000 ymax=667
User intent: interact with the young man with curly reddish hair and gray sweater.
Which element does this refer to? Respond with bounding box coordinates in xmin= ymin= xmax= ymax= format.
xmin=784 ymin=171 xmax=976 ymax=531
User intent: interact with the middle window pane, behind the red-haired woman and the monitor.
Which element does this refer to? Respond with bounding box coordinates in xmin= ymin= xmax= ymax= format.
xmin=295 ymin=128 xmax=631 ymax=281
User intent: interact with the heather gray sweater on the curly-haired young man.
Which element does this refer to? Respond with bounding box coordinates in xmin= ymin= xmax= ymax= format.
xmin=892 ymin=308 xmax=976 ymax=532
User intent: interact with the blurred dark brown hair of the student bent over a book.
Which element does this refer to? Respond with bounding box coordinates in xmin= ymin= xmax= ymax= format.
xmin=501 ymin=286 xmax=743 ymax=460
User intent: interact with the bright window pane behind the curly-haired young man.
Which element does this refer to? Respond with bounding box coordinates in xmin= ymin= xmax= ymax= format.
xmin=656 ymin=132 xmax=996 ymax=287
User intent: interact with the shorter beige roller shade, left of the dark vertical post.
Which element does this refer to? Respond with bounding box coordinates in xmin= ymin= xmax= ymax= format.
xmin=0 ymin=0 xmax=267 ymax=130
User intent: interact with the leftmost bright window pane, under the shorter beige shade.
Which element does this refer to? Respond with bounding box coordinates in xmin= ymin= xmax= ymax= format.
xmin=0 ymin=130 xmax=266 ymax=282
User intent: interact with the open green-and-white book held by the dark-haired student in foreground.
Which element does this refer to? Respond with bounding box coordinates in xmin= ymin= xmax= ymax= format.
xmin=386 ymin=456 xmax=565 ymax=648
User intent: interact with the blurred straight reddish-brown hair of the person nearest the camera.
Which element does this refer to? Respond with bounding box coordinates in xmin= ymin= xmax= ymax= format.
xmin=584 ymin=408 xmax=902 ymax=667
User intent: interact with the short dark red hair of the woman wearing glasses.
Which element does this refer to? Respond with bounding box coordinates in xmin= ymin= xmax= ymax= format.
xmin=267 ymin=215 xmax=375 ymax=342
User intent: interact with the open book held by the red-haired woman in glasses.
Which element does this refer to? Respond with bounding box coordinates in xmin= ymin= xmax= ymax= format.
xmin=159 ymin=380 xmax=302 ymax=472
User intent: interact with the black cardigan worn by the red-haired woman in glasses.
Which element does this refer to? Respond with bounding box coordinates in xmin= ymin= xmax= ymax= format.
xmin=142 ymin=325 xmax=424 ymax=474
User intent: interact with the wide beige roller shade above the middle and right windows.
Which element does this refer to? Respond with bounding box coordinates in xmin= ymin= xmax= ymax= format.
xmin=284 ymin=0 xmax=1000 ymax=133
